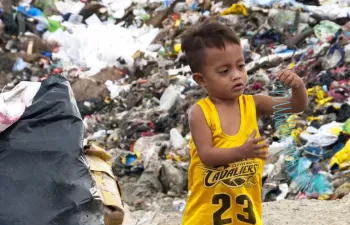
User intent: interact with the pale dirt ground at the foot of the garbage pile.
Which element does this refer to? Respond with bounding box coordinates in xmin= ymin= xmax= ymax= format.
xmin=123 ymin=195 xmax=350 ymax=225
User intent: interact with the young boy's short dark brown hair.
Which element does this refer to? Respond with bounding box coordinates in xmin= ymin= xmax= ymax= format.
xmin=181 ymin=19 xmax=241 ymax=73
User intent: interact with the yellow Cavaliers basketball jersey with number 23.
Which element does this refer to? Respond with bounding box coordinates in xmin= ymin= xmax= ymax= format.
xmin=183 ymin=95 xmax=264 ymax=225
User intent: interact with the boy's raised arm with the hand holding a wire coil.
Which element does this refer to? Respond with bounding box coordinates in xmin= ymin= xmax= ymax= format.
xmin=254 ymin=70 xmax=308 ymax=117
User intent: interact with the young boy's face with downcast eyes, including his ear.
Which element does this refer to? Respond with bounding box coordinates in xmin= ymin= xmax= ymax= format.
xmin=193 ymin=43 xmax=247 ymax=100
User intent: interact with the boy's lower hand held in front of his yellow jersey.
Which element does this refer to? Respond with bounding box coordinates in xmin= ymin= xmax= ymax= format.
xmin=242 ymin=130 xmax=268 ymax=159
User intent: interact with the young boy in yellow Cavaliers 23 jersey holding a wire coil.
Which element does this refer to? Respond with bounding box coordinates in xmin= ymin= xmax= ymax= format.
xmin=182 ymin=20 xmax=308 ymax=225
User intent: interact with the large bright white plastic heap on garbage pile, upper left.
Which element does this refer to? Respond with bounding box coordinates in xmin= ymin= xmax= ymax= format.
xmin=43 ymin=22 xmax=160 ymax=75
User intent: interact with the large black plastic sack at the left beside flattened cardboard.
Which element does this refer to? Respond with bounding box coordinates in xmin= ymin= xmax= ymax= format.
xmin=0 ymin=76 xmax=104 ymax=225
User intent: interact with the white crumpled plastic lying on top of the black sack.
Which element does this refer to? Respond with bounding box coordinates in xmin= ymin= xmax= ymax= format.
xmin=0 ymin=81 xmax=40 ymax=133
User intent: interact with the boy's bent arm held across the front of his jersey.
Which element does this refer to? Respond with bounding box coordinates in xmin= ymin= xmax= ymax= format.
xmin=189 ymin=104 xmax=267 ymax=166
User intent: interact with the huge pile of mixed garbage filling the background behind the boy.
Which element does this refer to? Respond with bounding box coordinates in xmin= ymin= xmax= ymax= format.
xmin=0 ymin=0 xmax=350 ymax=210
